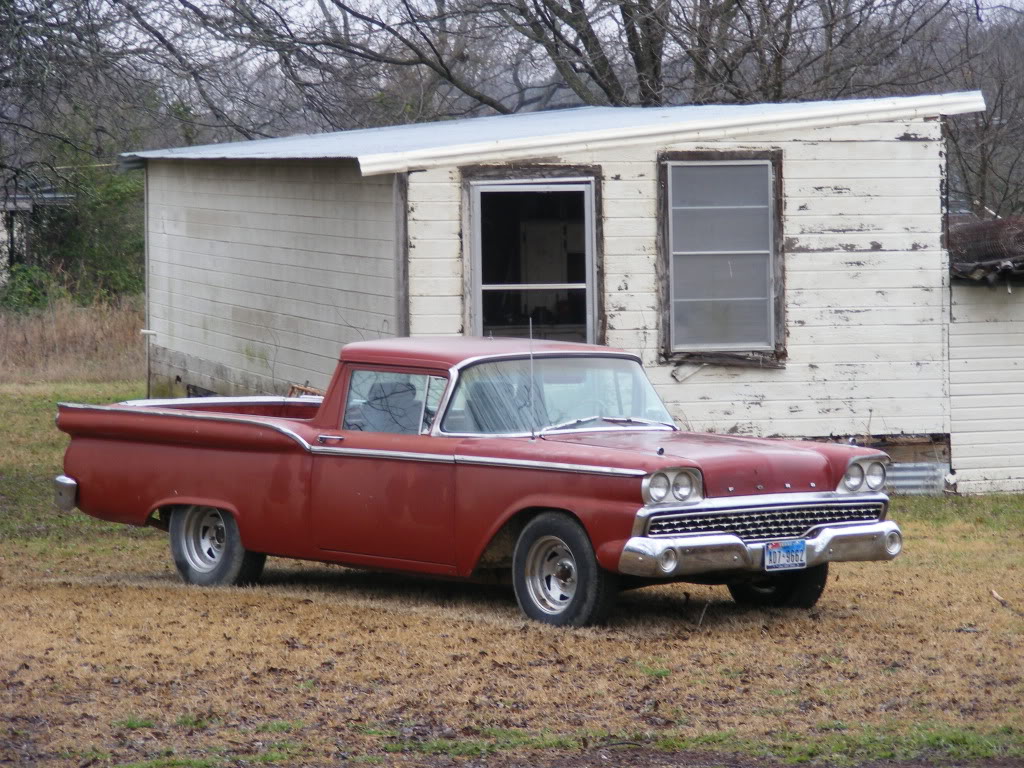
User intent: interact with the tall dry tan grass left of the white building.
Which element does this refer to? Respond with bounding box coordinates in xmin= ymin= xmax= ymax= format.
xmin=0 ymin=298 xmax=145 ymax=384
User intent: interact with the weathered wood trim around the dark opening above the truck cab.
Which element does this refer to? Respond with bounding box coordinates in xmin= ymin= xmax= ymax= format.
xmin=459 ymin=163 xmax=608 ymax=344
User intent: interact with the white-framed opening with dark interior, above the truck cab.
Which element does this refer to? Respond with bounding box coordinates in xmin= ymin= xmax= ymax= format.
xmin=472 ymin=181 xmax=594 ymax=342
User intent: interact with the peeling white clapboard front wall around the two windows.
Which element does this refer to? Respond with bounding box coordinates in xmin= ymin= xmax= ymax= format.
xmin=409 ymin=114 xmax=949 ymax=436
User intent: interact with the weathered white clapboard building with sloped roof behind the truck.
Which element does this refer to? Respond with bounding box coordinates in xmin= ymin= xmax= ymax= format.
xmin=124 ymin=92 xmax=1024 ymax=490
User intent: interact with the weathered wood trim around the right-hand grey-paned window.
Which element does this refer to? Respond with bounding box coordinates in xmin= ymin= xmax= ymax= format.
xmin=656 ymin=150 xmax=786 ymax=368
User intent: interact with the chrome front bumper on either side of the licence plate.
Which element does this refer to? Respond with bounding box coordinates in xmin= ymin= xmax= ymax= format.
xmin=618 ymin=520 xmax=903 ymax=579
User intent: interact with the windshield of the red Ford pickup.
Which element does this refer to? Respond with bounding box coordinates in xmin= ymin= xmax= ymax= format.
xmin=441 ymin=357 xmax=674 ymax=434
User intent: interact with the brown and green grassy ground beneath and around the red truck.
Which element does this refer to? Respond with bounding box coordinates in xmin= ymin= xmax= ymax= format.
xmin=0 ymin=383 xmax=1024 ymax=768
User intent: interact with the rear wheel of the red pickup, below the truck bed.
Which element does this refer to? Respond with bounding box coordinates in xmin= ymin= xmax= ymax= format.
xmin=170 ymin=507 xmax=266 ymax=587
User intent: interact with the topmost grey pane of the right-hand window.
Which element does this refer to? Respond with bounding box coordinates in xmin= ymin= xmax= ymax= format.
xmin=671 ymin=163 xmax=771 ymax=208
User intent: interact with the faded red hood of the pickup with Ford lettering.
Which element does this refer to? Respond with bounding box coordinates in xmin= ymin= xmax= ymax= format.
xmin=544 ymin=430 xmax=856 ymax=497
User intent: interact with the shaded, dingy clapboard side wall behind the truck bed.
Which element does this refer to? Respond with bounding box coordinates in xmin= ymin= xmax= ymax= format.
xmin=146 ymin=161 xmax=398 ymax=391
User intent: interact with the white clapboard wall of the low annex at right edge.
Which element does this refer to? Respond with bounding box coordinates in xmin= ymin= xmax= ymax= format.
xmin=949 ymin=284 xmax=1024 ymax=493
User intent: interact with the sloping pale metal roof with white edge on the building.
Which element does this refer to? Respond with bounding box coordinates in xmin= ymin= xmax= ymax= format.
xmin=121 ymin=91 xmax=985 ymax=176
